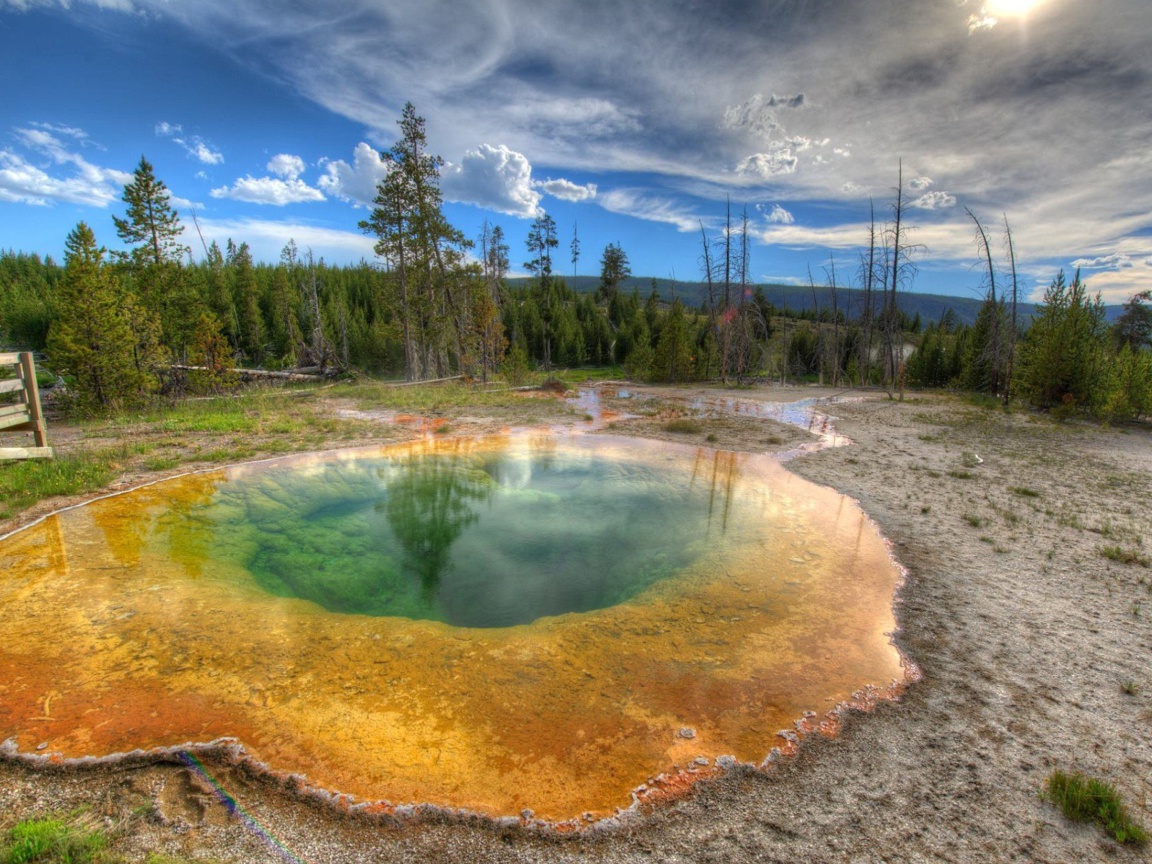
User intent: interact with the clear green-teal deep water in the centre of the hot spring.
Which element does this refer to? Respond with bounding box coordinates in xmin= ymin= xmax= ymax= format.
xmin=194 ymin=447 xmax=711 ymax=628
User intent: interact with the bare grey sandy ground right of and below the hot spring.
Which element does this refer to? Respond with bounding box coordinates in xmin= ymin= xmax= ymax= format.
xmin=0 ymin=388 xmax=1152 ymax=864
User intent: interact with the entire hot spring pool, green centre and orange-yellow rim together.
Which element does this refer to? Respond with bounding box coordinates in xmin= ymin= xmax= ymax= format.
xmin=0 ymin=432 xmax=908 ymax=823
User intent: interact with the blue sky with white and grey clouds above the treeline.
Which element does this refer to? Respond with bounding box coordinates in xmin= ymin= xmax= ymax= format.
xmin=0 ymin=0 xmax=1152 ymax=303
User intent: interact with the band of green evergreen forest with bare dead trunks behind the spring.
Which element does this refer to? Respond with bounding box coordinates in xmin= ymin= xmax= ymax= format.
xmin=0 ymin=105 xmax=1152 ymax=419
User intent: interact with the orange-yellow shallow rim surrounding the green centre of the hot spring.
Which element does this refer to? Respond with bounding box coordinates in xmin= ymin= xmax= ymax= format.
xmin=0 ymin=434 xmax=905 ymax=820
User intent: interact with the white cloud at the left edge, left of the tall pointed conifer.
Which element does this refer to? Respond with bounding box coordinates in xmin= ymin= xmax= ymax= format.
xmin=0 ymin=123 xmax=131 ymax=207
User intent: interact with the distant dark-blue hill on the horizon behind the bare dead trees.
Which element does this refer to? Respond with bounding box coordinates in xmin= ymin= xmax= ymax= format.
xmin=508 ymin=276 xmax=1122 ymax=325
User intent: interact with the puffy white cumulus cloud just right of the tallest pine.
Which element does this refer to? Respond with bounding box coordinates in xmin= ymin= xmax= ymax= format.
xmin=440 ymin=144 xmax=540 ymax=219
